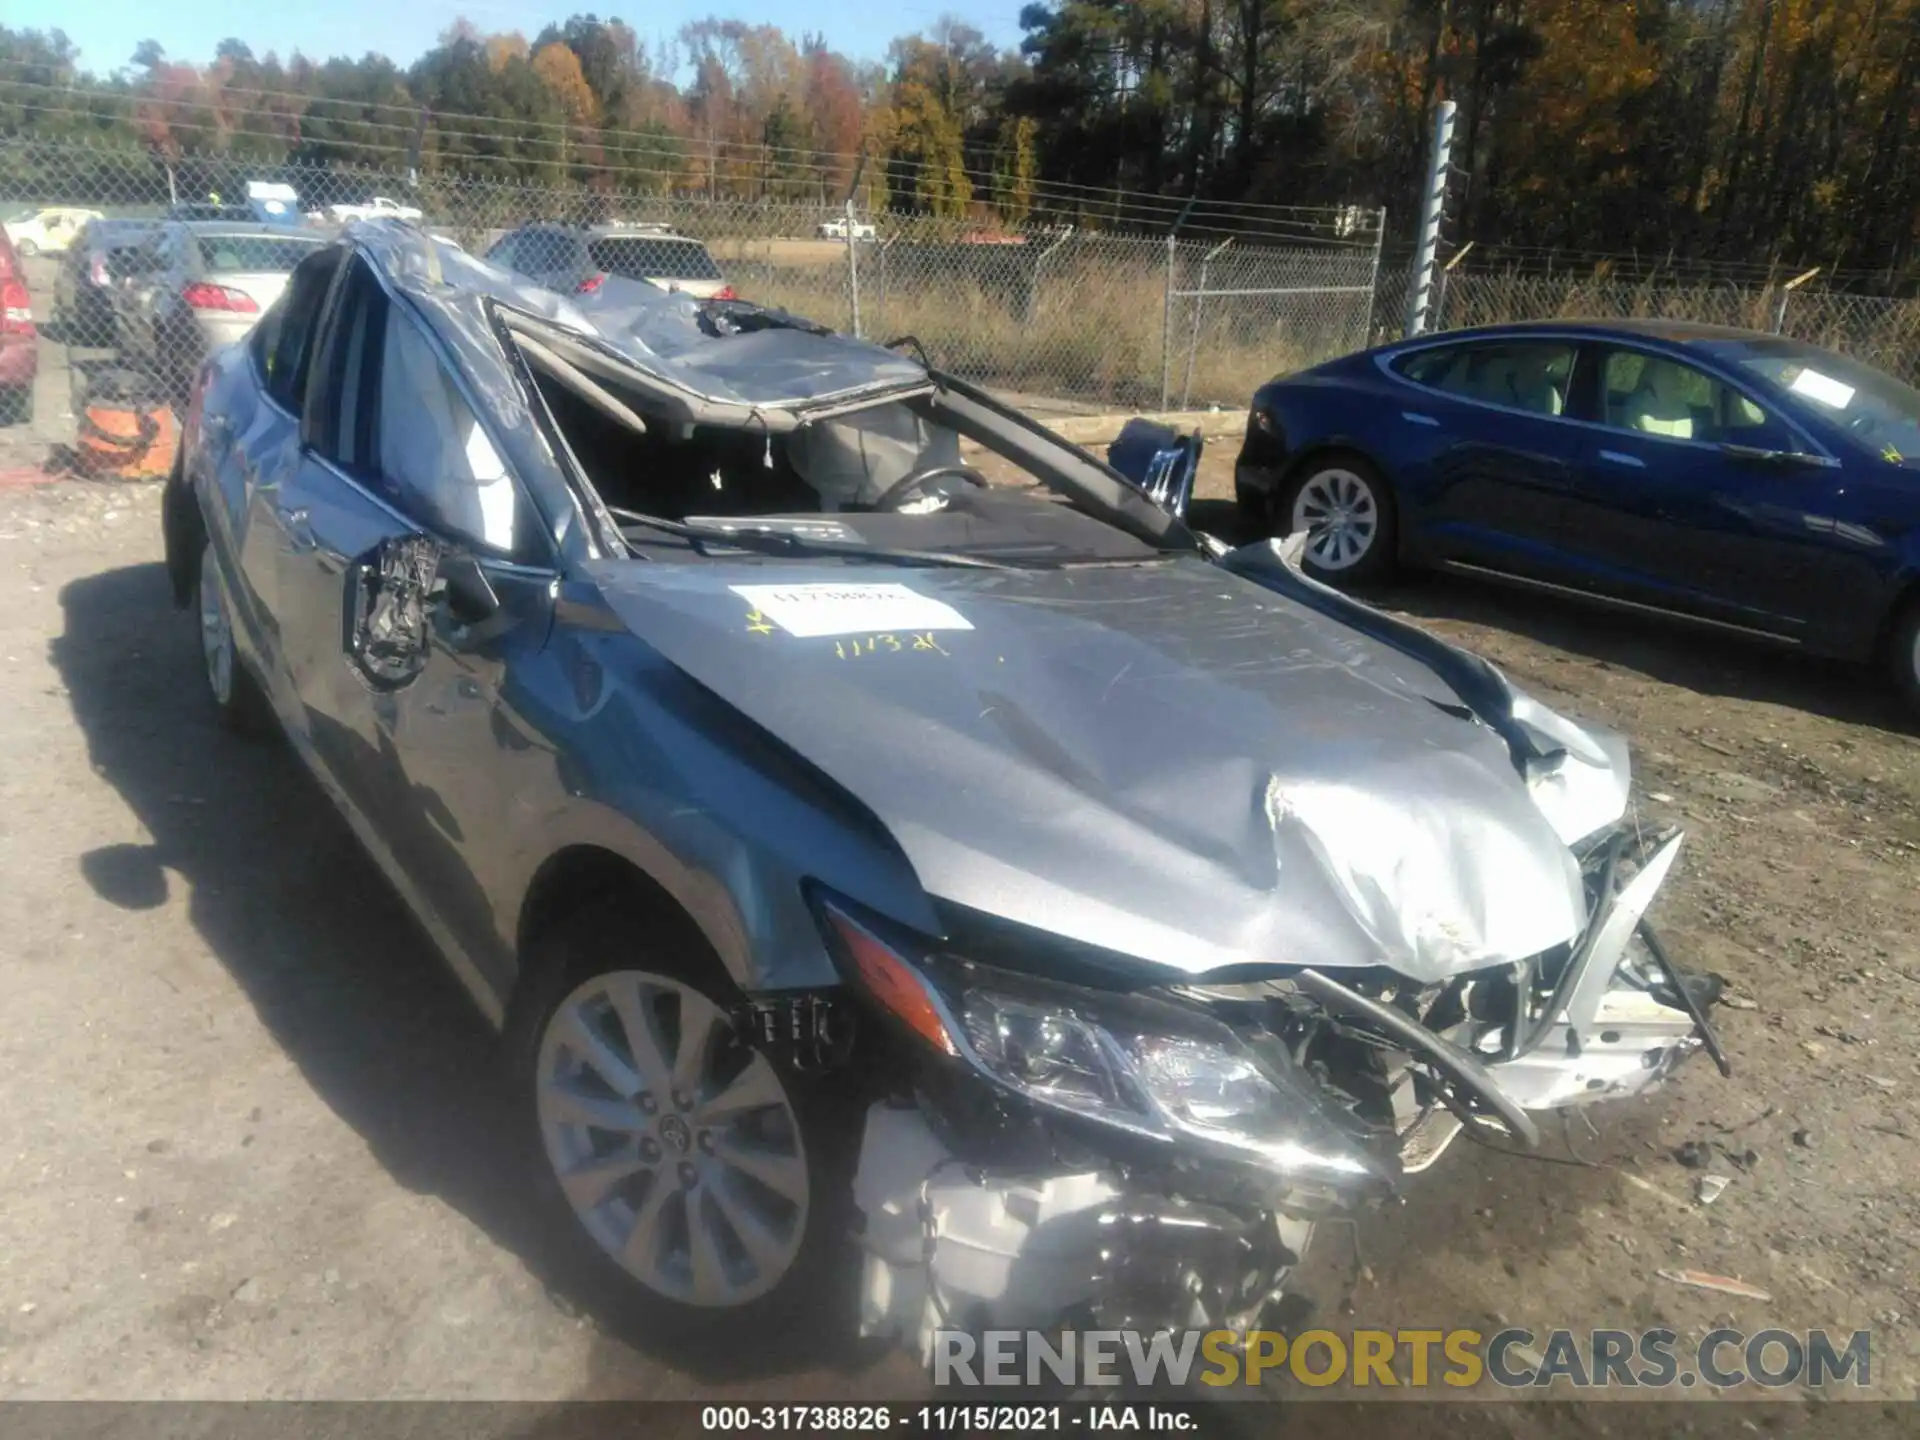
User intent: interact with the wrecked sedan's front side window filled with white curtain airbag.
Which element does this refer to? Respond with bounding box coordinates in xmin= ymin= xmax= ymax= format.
xmin=380 ymin=305 xmax=522 ymax=555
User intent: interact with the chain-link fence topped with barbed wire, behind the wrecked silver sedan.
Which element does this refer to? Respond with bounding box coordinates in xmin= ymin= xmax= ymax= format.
xmin=0 ymin=140 xmax=1382 ymax=468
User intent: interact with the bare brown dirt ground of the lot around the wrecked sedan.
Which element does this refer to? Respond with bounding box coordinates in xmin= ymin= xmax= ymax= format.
xmin=0 ymin=445 xmax=1920 ymax=1434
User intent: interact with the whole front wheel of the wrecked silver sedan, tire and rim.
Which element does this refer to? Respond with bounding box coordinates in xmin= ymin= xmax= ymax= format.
xmin=513 ymin=902 xmax=858 ymax=1334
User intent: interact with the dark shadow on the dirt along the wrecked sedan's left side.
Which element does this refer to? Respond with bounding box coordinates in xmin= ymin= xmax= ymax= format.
xmin=52 ymin=564 xmax=890 ymax=1394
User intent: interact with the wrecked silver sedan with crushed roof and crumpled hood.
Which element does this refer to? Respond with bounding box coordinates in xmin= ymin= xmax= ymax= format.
xmin=165 ymin=223 xmax=1715 ymax=1346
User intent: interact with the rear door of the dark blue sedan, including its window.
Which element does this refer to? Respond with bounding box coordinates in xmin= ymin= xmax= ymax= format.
xmin=1390 ymin=336 xmax=1578 ymax=576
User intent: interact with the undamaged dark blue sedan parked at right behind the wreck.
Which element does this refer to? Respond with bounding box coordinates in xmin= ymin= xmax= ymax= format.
xmin=1235 ymin=321 xmax=1920 ymax=705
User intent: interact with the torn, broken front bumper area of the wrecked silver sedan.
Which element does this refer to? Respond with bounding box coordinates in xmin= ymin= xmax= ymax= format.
xmin=854 ymin=821 xmax=1724 ymax=1359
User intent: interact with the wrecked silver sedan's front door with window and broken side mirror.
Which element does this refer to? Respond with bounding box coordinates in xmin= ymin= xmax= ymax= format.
xmin=282 ymin=257 xmax=555 ymax=979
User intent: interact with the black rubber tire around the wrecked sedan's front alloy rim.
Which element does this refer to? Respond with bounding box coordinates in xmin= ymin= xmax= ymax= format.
xmin=507 ymin=897 xmax=860 ymax=1346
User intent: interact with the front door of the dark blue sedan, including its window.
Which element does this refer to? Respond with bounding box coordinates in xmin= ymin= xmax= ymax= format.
xmin=1565 ymin=342 xmax=1853 ymax=636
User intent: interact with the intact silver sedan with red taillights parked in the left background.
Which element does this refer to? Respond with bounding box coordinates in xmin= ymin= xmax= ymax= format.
xmin=108 ymin=221 xmax=326 ymax=390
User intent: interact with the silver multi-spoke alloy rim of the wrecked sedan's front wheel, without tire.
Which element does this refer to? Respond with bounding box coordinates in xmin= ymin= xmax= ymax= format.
xmin=534 ymin=970 xmax=808 ymax=1309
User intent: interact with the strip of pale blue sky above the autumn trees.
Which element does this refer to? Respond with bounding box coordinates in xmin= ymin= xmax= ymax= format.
xmin=6 ymin=0 xmax=1021 ymax=73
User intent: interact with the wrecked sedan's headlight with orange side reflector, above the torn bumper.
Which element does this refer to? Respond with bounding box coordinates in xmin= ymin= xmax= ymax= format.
xmin=822 ymin=902 xmax=1384 ymax=1183
